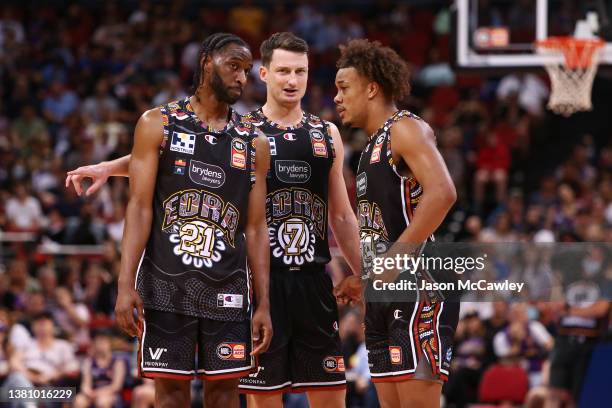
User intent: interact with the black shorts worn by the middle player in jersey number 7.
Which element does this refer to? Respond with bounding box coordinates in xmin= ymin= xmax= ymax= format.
xmin=239 ymin=267 xmax=346 ymax=394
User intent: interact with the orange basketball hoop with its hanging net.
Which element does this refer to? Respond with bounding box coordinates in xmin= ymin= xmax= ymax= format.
xmin=535 ymin=37 xmax=605 ymax=116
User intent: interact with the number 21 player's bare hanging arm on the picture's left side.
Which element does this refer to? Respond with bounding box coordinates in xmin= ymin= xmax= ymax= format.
xmin=115 ymin=109 xmax=163 ymax=336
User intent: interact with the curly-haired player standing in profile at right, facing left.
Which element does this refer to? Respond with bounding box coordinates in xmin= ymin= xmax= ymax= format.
xmin=334 ymin=40 xmax=459 ymax=408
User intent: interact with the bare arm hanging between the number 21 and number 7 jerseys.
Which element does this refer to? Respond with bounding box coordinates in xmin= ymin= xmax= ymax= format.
xmin=246 ymin=135 xmax=272 ymax=356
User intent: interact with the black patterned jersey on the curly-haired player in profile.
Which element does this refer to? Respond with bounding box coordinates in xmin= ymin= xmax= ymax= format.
xmin=356 ymin=111 xmax=433 ymax=270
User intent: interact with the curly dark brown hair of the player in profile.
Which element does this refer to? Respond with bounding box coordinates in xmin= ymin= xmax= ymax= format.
xmin=336 ymin=39 xmax=410 ymax=102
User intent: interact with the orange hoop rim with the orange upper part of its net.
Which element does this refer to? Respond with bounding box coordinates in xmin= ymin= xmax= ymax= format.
xmin=535 ymin=36 xmax=605 ymax=69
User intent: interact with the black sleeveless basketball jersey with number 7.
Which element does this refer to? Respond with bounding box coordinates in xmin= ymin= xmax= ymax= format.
xmin=243 ymin=109 xmax=335 ymax=268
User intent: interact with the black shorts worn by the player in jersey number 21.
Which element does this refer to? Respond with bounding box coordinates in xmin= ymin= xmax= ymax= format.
xmin=138 ymin=309 xmax=253 ymax=380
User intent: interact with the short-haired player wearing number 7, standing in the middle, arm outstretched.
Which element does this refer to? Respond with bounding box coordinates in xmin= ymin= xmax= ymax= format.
xmin=66 ymin=33 xmax=360 ymax=407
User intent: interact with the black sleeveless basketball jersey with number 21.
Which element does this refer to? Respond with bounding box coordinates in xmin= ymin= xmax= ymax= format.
xmin=136 ymin=98 xmax=255 ymax=321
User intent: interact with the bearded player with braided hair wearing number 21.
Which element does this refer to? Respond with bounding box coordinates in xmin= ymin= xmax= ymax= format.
xmin=115 ymin=33 xmax=272 ymax=407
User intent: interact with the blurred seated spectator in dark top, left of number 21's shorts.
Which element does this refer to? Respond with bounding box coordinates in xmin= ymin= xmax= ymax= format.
xmin=74 ymin=331 xmax=127 ymax=408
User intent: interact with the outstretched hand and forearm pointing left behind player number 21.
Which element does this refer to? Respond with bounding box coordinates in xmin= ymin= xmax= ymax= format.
xmin=66 ymin=154 xmax=131 ymax=196
